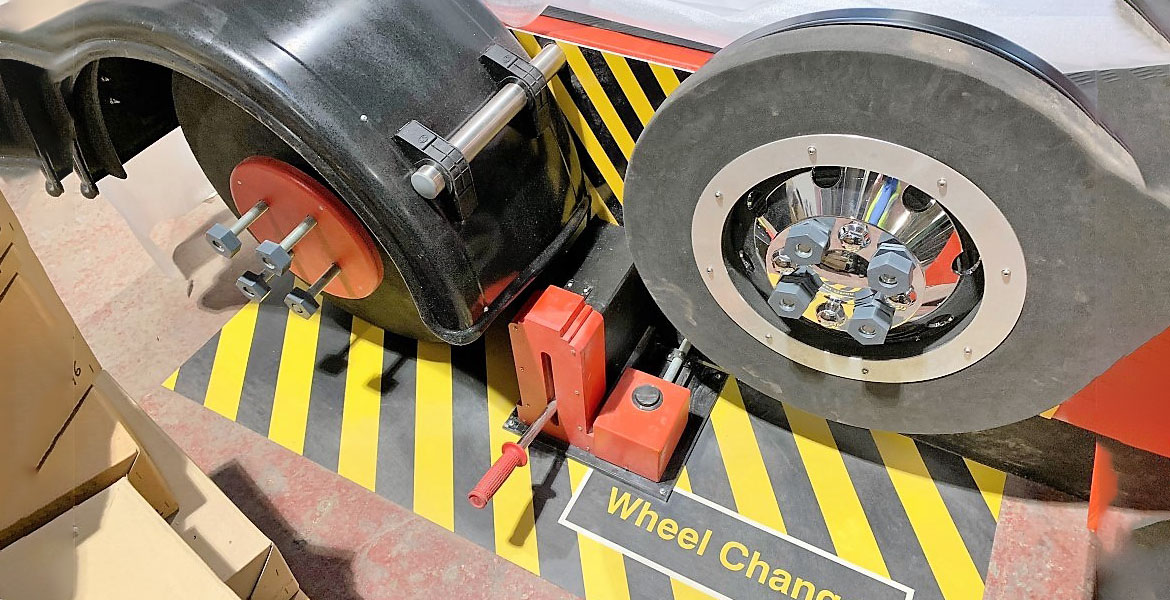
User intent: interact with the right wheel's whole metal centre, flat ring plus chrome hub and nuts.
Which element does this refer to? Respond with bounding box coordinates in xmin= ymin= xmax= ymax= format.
xmin=690 ymin=135 xmax=1026 ymax=382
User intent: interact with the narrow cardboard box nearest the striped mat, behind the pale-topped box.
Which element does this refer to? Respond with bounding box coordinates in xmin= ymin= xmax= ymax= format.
xmin=94 ymin=372 xmax=300 ymax=600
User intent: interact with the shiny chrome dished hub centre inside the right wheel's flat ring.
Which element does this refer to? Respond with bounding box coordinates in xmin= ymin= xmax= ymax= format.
xmin=744 ymin=166 xmax=963 ymax=344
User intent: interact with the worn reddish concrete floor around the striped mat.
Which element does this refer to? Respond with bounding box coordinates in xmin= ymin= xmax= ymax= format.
xmin=0 ymin=161 xmax=1155 ymax=600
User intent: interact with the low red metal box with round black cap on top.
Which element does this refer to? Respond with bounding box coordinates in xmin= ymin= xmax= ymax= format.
xmin=593 ymin=368 xmax=690 ymax=481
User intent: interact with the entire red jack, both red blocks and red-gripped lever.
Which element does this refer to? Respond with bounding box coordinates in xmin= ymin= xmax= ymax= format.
xmin=468 ymin=285 xmax=690 ymax=508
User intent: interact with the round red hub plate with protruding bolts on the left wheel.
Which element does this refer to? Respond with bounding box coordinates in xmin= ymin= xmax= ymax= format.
xmin=232 ymin=157 xmax=383 ymax=298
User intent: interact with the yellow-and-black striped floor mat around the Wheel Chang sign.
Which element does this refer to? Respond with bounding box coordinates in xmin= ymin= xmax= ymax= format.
xmin=165 ymin=302 xmax=1005 ymax=600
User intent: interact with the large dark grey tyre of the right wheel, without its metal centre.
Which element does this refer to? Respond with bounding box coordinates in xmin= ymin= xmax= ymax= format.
xmin=625 ymin=14 xmax=1170 ymax=433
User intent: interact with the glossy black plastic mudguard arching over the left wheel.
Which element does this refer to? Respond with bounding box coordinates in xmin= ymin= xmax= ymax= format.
xmin=0 ymin=0 xmax=589 ymax=344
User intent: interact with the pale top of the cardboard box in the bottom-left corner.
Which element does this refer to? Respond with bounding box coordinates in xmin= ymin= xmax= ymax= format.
xmin=0 ymin=480 xmax=236 ymax=600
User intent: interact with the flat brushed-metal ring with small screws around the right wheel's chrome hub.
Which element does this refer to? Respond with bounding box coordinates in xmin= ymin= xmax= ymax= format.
xmin=690 ymin=135 xmax=1027 ymax=384
